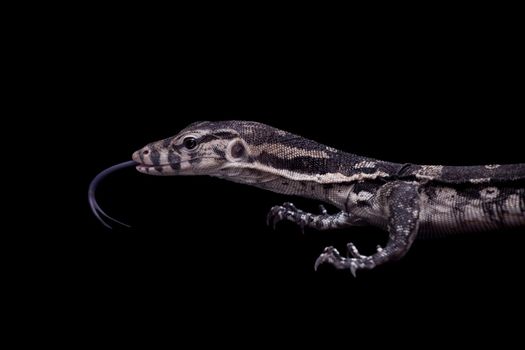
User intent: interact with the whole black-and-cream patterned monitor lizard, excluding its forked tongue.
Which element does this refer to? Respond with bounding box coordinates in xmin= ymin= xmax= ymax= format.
xmin=112 ymin=121 xmax=525 ymax=275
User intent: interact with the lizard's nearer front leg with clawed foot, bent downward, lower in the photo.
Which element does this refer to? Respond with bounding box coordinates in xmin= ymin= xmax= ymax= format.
xmin=315 ymin=182 xmax=419 ymax=276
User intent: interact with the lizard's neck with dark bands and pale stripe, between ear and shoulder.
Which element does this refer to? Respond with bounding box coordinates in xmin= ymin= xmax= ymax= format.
xmin=210 ymin=126 xmax=402 ymax=208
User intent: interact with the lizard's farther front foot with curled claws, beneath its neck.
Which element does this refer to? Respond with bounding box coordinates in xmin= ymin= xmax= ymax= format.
xmin=267 ymin=203 xmax=351 ymax=231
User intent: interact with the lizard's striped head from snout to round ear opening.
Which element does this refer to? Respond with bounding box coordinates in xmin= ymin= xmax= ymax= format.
xmin=133 ymin=121 xmax=257 ymax=177
